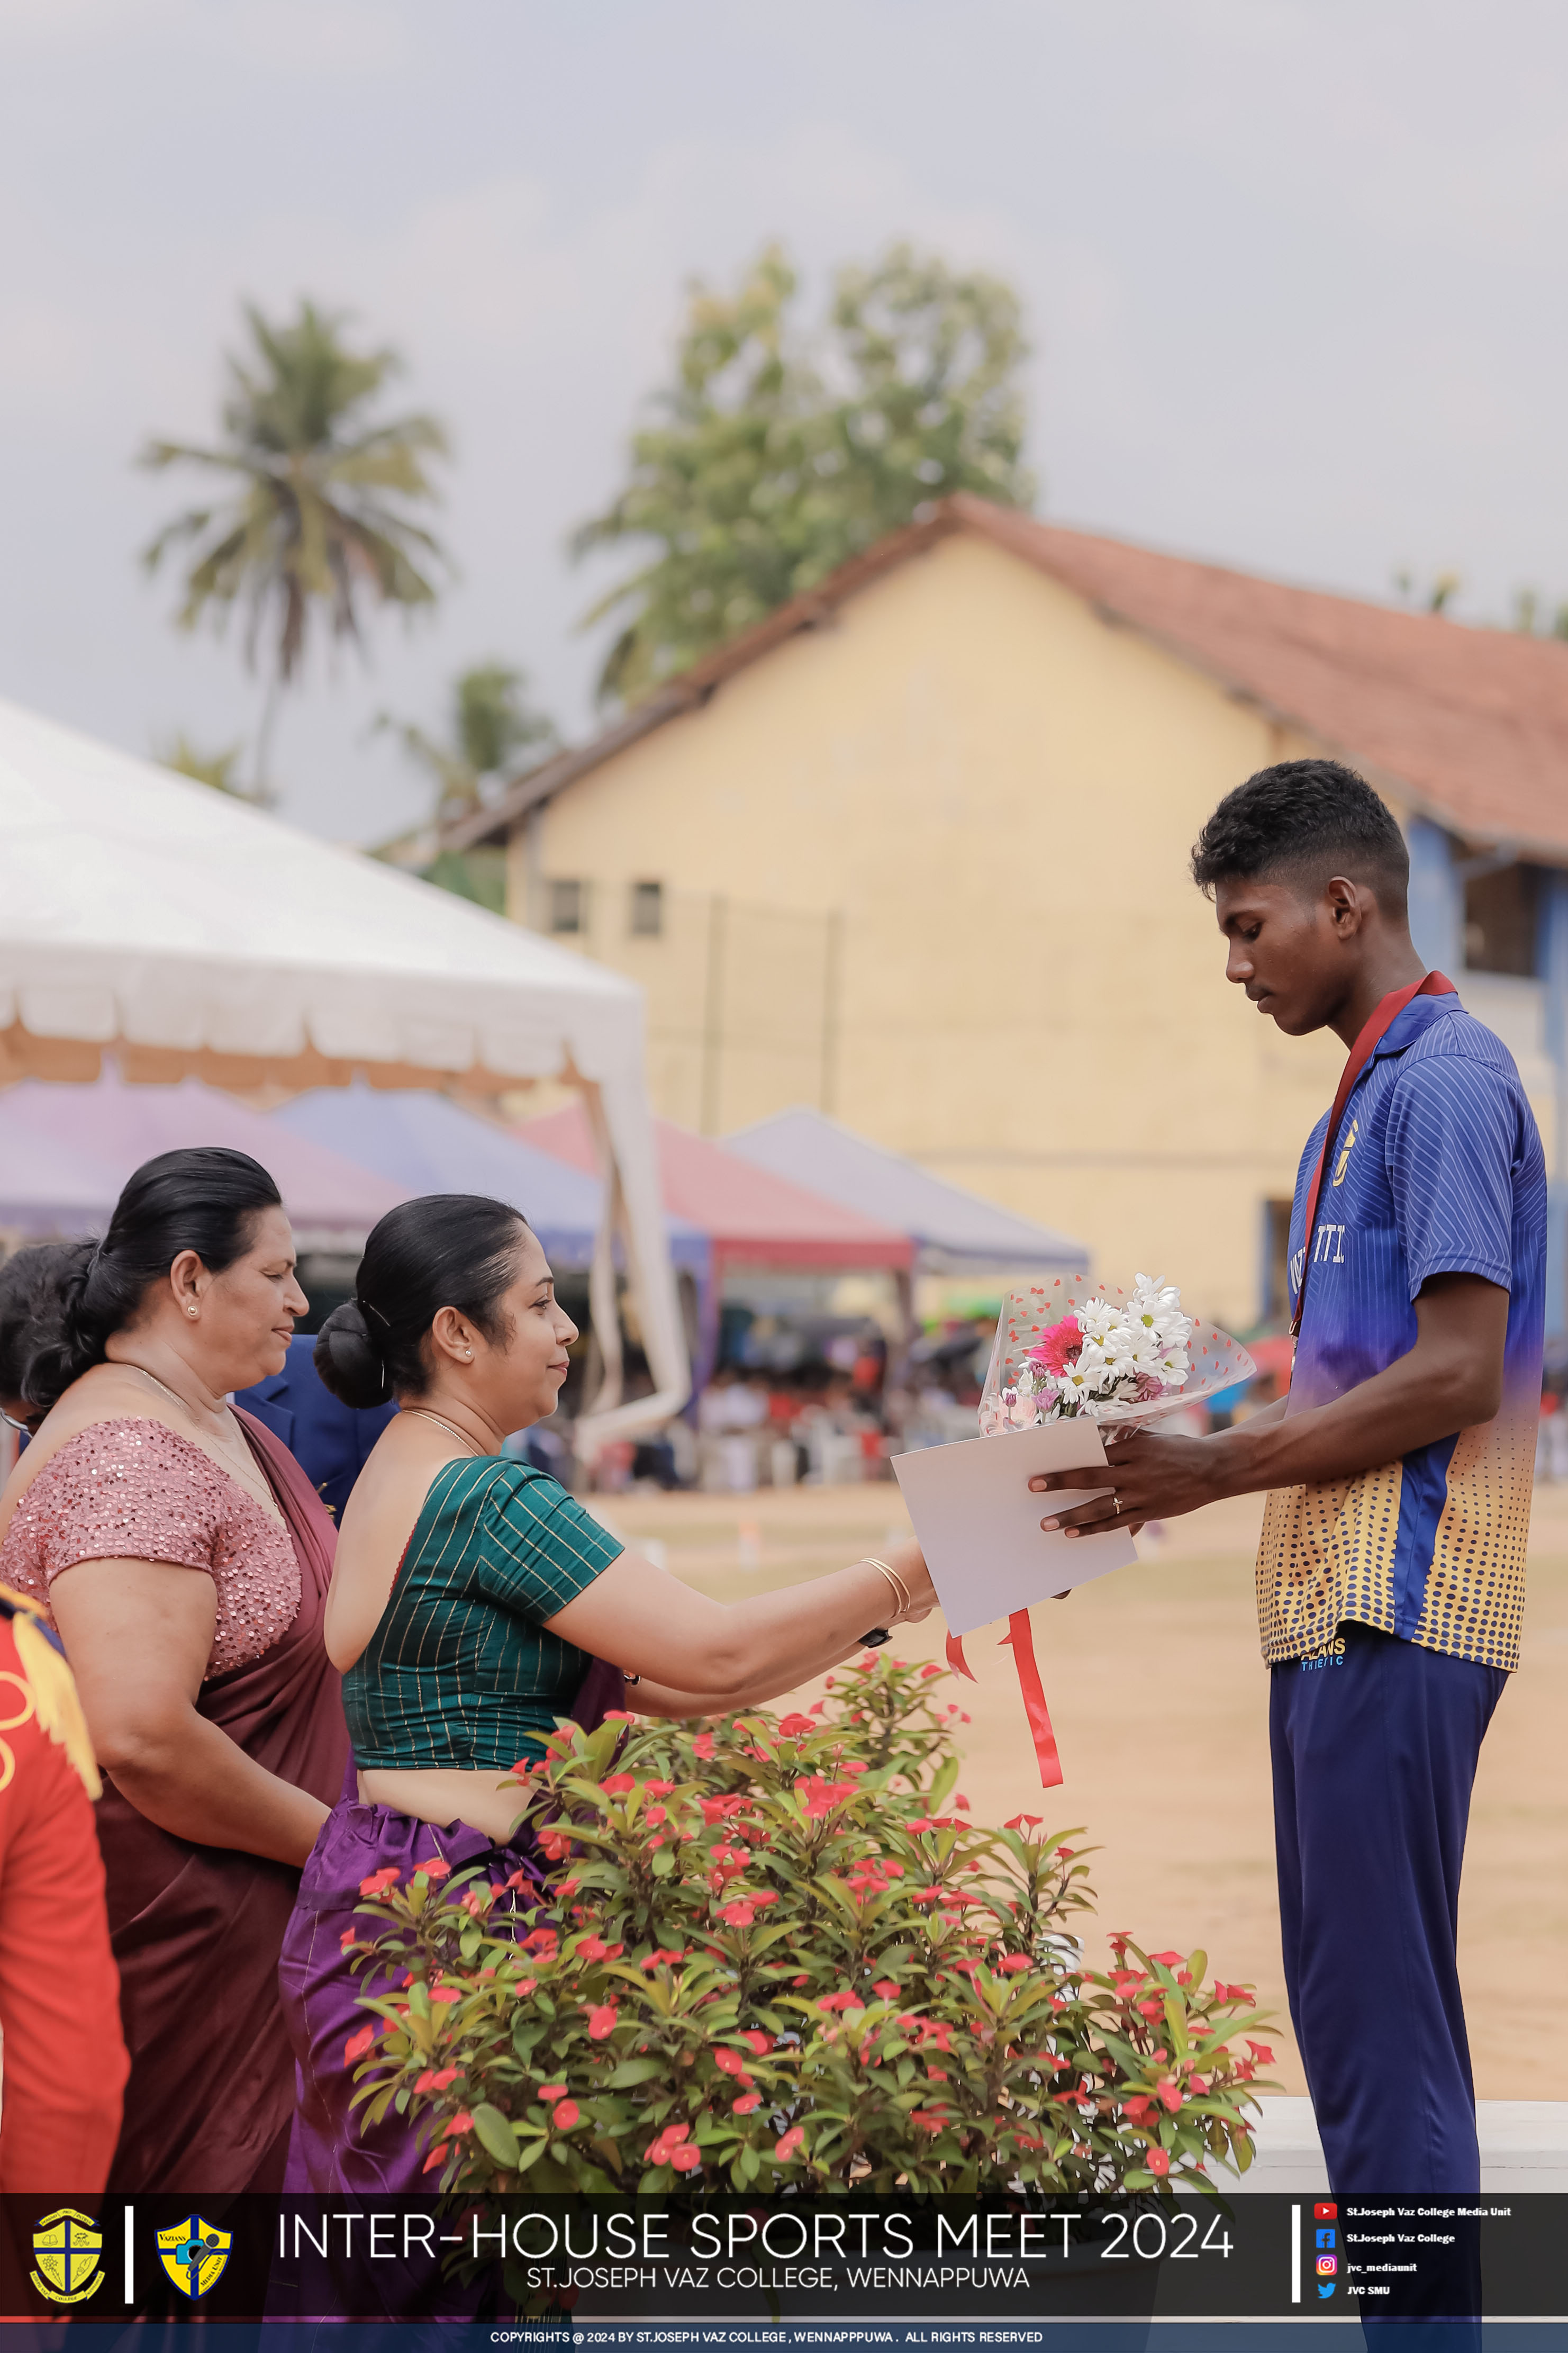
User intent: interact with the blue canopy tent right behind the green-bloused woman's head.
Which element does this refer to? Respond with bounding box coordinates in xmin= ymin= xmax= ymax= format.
xmin=273 ymin=1085 xmax=708 ymax=1283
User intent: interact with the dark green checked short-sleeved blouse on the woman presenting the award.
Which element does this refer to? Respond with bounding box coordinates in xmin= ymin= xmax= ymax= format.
xmin=343 ymin=1454 xmax=623 ymax=1772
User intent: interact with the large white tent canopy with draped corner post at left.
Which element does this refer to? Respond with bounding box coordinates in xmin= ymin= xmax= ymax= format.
xmin=0 ymin=701 xmax=689 ymax=1440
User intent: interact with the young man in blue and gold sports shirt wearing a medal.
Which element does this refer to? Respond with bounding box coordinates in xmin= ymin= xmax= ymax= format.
xmin=1032 ymin=760 xmax=1547 ymax=2193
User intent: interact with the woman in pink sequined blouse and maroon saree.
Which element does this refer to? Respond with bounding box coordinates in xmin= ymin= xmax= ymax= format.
xmin=0 ymin=1151 xmax=348 ymax=2195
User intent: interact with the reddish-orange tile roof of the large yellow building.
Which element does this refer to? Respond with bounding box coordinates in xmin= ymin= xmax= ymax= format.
xmin=447 ymin=494 xmax=1568 ymax=859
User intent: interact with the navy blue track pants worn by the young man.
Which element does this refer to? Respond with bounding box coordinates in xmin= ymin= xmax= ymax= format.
xmin=1270 ymin=1624 xmax=1507 ymax=2195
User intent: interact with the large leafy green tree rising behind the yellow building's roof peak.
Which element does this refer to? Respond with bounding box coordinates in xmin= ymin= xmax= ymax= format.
xmin=574 ymin=245 xmax=1035 ymax=704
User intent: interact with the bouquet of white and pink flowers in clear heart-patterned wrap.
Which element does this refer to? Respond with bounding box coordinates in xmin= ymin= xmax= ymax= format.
xmin=980 ymin=1275 xmax=1258 ymax=1438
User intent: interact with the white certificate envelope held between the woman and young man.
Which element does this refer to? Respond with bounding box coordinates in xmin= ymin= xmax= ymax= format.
xmin=893 ymin=1414 xmax=1138 ymax=1633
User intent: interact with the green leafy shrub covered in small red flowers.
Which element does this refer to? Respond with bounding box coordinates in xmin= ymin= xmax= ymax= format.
xmin=355 ymin=1652 xmax=1272 ymax=2190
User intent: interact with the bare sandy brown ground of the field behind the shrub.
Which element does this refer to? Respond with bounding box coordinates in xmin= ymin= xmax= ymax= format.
xmin=597 ymin=1485 xmax=1568 ymax=2099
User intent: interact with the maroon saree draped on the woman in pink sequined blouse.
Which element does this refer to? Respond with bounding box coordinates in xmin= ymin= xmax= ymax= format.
xmin=99 ymin=1410 xmax=348 ymax=2198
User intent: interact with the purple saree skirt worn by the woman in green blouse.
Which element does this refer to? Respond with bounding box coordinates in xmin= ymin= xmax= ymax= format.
xmin=277 ymin=1659 xmax=626 ymax=2195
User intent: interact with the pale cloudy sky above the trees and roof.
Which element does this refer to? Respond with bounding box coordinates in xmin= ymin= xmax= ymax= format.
xmin=0 ymin=0 xmax=1568 ymax=840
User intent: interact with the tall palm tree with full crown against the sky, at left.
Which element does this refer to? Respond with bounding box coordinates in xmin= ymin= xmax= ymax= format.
xmin=141 ymin=301 xmax=447 ymax=798
